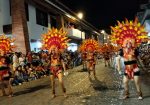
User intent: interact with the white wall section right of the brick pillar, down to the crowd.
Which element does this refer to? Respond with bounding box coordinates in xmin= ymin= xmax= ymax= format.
xmin=27 ymin=4 xmax=51 ymax=52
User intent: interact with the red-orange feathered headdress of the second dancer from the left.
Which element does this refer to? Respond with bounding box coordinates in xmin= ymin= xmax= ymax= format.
xmin=42 ymin=28 xmax=69 ymax=50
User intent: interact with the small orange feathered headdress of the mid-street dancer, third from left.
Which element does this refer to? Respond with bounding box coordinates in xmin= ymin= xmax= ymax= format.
xmin=79 ymin=39 xmax=100 ymax=52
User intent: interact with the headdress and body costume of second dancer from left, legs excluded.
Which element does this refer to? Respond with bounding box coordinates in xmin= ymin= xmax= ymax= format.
xmin=42 ymin=28 xmax=69 ymax=77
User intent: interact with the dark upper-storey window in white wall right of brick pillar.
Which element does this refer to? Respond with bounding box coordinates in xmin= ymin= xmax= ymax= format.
xmin=36 ymin=8 xmax=48 ymax=27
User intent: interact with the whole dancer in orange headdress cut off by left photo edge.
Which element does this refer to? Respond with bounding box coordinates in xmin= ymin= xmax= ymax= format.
xmin=0 ymin=35 xmax=14 ymax=97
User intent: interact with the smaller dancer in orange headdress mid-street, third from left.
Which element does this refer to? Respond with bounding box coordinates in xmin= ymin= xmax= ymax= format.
xmin=79 ymin=39 xmax=100 ymax=79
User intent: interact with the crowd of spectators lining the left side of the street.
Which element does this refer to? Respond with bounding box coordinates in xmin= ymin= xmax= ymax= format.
xmin=3 ymin=50 xmax=78 ymax=86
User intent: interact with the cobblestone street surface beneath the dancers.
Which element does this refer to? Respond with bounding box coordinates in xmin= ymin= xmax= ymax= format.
xmin=0 ymin=62 xmax=150 ymax=105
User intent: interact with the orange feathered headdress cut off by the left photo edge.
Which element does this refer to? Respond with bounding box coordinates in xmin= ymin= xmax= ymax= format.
xmin=0 ymin=34 xmax=15 ymax=53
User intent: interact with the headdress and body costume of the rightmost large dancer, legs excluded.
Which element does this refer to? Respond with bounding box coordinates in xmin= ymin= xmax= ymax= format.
xmin=111 ymin=18 xmax=147 ymax=79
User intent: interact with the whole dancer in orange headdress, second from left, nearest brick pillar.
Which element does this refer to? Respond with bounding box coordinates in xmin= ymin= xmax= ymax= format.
xmin=42 ymin=28 xmax=69 ymax=98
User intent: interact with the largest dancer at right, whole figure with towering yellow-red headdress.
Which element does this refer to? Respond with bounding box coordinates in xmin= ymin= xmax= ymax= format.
xmin=111 ymin=18 xmax=147 ymax=99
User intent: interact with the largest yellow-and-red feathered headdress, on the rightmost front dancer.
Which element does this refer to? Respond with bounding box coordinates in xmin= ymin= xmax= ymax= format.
xmin=111 ymin=18 xmax=147 ymax=47
